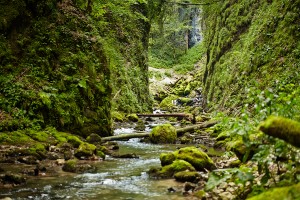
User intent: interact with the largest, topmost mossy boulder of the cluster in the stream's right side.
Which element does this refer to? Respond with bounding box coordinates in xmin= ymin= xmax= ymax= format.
xmin=174 ymin=147 xmax=216 ymax=171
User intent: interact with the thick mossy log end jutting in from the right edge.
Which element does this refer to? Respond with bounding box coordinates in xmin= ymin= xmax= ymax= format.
xmin=259 ymin=116 xmax=300 ymax=148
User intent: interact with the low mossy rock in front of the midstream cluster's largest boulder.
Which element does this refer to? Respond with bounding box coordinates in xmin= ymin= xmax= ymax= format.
xmin=158 ymin=160 xmax=195 ymax=177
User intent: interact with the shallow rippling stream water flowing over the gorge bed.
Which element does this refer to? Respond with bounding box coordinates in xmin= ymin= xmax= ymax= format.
xmin=0 ymin=122 xmax=192 ymax=200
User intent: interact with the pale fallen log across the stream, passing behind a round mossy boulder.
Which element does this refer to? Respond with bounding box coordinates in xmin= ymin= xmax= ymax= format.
xmin=101 ymin=121 xmax=218 ymax=142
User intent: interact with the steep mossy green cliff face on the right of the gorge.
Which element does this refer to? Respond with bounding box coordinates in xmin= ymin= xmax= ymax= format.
xmin=203 ymin=0 xmax=300 ymax=114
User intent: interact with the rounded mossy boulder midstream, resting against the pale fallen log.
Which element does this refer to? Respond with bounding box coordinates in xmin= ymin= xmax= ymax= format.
xmin=149 ymin=124 xmax=177 ymax=144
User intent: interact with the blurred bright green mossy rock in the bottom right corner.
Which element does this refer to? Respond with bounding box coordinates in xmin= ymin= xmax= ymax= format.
xmin=248 ymin=183 xmax=300 ymax=200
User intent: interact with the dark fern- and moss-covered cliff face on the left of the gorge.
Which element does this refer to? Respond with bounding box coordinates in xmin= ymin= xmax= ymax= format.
xmin=0 ymin=0 xmax=150 ymax=136
